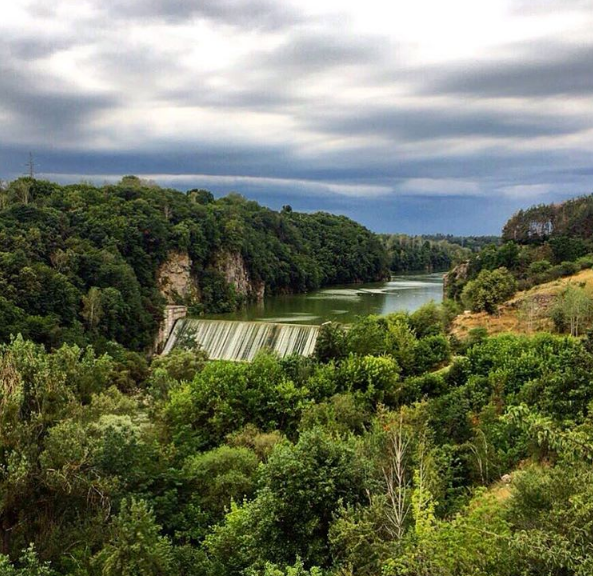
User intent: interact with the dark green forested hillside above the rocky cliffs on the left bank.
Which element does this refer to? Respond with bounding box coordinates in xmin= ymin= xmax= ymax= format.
xmin=0 ymin=177 xmax=387 ymax=351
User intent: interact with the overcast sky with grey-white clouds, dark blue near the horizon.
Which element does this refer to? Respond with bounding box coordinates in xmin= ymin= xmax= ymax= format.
xmin=0 ymin=0 xmax=593 ymax=235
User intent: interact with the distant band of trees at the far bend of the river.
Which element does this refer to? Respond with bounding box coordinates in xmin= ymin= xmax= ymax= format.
xmin=381 ymin=234 xmax=471 ymax=273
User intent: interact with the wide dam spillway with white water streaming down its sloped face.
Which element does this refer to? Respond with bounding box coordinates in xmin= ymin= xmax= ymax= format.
xmin=163 ymin=318 xmax=320 ymax=362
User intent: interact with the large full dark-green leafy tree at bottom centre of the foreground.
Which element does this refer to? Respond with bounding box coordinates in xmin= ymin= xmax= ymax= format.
xmin=206 ymin=429 xmax=365 ymax=575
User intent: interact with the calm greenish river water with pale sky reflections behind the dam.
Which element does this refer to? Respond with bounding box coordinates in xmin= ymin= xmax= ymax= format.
xmin=204 ymin=274 xmax=443 ymax=324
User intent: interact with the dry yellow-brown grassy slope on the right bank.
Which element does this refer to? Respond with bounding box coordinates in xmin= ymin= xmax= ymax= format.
xmin=451 ymin=270 xmax=593 ymax=338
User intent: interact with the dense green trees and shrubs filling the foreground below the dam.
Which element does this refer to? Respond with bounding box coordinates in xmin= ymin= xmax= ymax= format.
xmin=0 ymin=305 xmax=593 ymax=576
